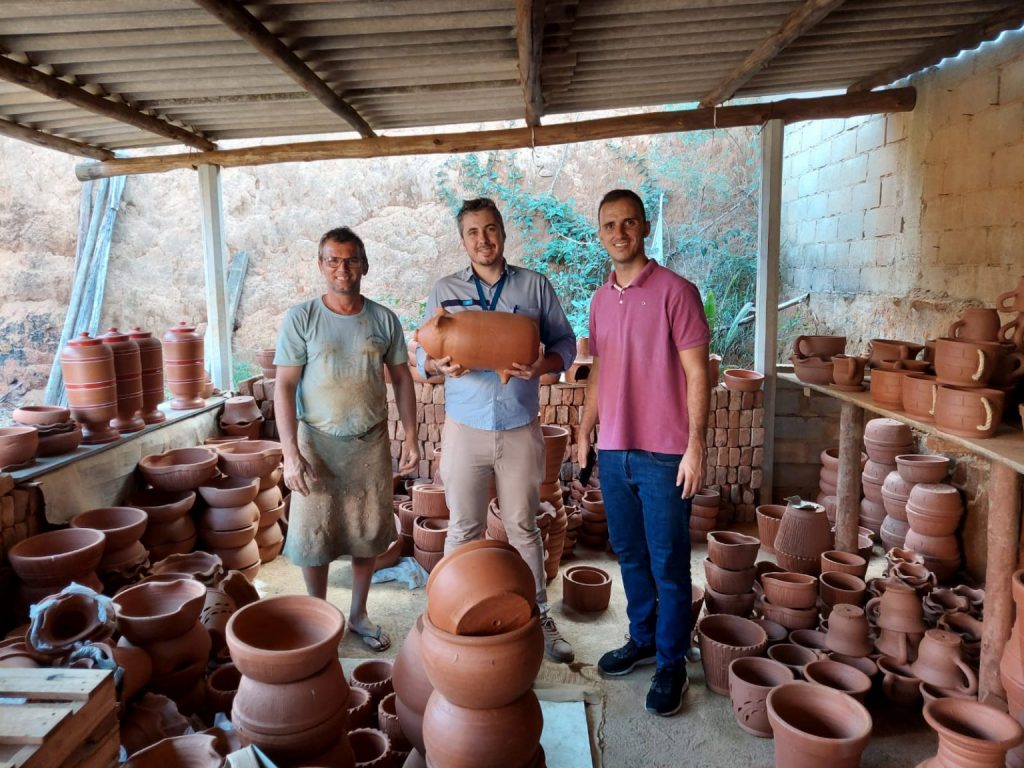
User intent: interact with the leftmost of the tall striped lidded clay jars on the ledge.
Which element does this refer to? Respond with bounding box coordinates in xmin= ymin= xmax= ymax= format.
xmin=60 ymin=332 xmax=121 ymax=444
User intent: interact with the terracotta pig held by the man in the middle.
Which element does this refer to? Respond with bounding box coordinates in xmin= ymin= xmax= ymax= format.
xmin=414 ymin=307 xmax=541 ymax=384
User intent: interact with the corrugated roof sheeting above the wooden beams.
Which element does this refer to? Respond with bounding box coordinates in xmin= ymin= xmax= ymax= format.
xmin=0 ymin=0 xmax=1024 ymax=157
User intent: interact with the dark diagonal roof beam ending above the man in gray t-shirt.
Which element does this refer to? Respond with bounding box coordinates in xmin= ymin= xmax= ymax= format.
xmin=193 ymin=0 xmax=377 ymax=138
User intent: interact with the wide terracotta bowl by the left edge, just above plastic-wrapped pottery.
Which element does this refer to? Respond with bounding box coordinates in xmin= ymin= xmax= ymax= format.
xmin=7 ymin=528 xmax=106 ymax=585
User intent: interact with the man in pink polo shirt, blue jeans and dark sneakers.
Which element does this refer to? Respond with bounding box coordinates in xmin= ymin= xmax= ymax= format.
xmin=577 ymin=189 xmax=710 ymax=716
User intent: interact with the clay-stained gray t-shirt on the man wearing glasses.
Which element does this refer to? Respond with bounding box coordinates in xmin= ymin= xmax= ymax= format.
xmin=273 ymin=297 xmax=409 ymax=437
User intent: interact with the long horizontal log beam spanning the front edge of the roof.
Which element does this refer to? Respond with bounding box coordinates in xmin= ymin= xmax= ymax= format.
xmin=75 ymin=88 xmax=916 ymax=181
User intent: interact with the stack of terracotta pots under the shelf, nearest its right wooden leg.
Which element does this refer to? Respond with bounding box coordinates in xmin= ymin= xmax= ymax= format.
xmin=905 ymin=482 xmax=964 ymax=582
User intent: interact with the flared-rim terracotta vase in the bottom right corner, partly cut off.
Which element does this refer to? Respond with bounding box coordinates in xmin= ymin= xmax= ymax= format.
xmin=925 ymin=698 xmax=1024 ymax=768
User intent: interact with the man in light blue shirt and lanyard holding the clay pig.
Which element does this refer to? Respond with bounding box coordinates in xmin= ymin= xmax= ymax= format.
xmin=417 ymin=198 xmax=575 ymax=662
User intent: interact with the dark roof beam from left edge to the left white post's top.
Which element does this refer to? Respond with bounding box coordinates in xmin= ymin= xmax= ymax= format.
xmin=0 ymin=55 xmax=217 ymax=152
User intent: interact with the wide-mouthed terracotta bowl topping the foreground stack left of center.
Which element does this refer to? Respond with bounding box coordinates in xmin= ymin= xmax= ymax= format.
xmin=226 ymin=595 xmax=345 ymax=683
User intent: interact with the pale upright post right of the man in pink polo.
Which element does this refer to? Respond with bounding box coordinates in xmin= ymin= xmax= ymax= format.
xmin=754 ymin=120 xmax=785 ymax=504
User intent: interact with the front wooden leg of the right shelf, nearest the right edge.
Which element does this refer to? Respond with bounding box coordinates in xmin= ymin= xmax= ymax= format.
xmin=978 ymin=461 xmax=1021 ymax=701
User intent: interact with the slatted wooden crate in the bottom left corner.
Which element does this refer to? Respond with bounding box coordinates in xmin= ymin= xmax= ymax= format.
xmin=0 ymin=668 xmax=121 ymax=768
